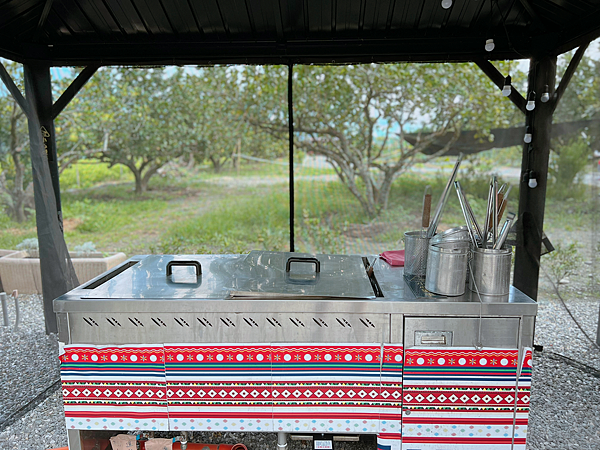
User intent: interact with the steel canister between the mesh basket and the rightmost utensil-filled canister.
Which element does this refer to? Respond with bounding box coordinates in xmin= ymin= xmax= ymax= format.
xmin=425 ymin=241 xmax=470 ymax=296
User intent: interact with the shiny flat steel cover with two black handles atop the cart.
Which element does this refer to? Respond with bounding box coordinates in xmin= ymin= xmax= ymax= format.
xmin=83 ymin=251 xmax=375 ymax=300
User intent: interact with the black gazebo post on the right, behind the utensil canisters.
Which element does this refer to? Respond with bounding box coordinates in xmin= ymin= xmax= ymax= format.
xmin=513 ymin=55 xmax=556 ymax=299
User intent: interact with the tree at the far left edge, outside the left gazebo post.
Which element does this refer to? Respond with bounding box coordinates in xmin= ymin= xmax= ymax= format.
xmin=0 ymin=62 xmax=33 ymax=222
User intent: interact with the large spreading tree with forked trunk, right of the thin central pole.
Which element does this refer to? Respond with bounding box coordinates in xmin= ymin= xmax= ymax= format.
xmin=246 ymin=64 xmax=516 ymax=217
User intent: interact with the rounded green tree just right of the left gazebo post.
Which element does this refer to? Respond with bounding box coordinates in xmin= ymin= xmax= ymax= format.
xmin=58 ymin=68 xmax=198 ymax=194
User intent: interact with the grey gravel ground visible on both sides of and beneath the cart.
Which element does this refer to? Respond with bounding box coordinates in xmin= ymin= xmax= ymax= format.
xmin=0 ymin=285 xmax=600 ymax=450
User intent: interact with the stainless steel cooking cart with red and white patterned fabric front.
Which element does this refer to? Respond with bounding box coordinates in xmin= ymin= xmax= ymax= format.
xmin=54 ymin=251 xmax=537 ymax=450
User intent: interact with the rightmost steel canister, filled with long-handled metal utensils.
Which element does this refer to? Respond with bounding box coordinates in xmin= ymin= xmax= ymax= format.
xmin=469 ymin=247 xmax=512 ymax=301
